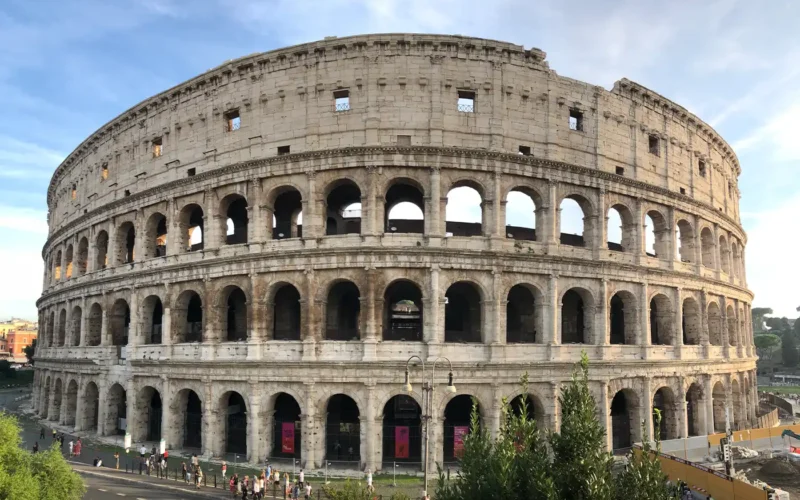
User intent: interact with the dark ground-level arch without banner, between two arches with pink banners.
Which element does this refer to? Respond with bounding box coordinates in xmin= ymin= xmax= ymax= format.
xmin=325 ymin=394 xmax=361 ymax=463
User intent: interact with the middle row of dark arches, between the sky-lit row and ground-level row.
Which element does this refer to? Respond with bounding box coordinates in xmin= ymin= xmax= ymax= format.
xmin=41 ymin=279 xmax=749 ymax=346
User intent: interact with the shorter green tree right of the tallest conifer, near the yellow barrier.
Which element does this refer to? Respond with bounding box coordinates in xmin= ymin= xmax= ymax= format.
xmin=614 ymin=408 xmax=680 ymax=500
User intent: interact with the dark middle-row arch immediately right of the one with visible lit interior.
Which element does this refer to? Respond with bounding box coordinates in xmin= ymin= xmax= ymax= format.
xmin=444 ymin=281 xmax=483 ymax=342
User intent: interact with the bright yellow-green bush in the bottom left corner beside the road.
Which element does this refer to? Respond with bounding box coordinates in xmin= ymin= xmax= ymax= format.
xmin=0 ymin=413 xmax=86 ymax=500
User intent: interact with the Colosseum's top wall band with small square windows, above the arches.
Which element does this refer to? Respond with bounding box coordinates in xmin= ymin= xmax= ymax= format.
xmin=47 ymin=34 xmax=740 ymax=233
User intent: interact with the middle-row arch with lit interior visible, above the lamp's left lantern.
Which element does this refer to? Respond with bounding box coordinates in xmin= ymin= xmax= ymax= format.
xmin=383 ymin=280 xmax=422 ymax=341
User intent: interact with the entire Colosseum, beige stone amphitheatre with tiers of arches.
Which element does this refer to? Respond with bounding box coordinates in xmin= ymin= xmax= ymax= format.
xmin=34 ymin=34 xmax=757 ymax=471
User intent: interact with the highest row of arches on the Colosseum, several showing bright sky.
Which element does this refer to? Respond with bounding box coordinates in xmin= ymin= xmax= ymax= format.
xmin=48 ymin=178 xmax=744 ymax=281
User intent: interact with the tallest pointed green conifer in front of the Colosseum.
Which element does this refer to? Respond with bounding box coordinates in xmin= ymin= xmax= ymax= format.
xmin=550 ymin=352 xmax=616 ymax=500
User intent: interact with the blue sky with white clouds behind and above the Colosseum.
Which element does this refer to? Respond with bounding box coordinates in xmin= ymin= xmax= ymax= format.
xmin=0 ymin=0 xmax=800 ymax=318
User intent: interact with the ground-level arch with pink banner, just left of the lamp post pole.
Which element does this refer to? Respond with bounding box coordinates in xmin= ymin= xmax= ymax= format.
xmin=383 ymin=394 xmax=422 ymax=467
